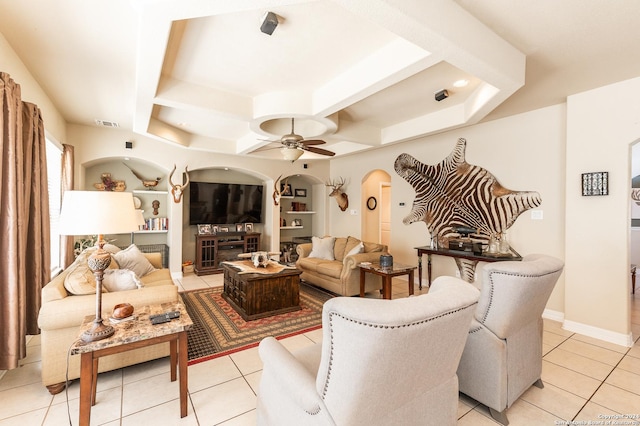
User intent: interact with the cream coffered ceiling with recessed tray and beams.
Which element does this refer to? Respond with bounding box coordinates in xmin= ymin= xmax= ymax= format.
xmin=0 ymin=0 xmax=640 ymax=159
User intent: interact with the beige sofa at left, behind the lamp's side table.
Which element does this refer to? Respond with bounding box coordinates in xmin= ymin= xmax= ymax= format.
xmin=38 ymin=246 xmax=178 ymax=395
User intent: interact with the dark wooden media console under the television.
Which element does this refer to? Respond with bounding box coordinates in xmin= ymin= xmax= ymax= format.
xmin=194 ymin=232 xmax=261 ymax=275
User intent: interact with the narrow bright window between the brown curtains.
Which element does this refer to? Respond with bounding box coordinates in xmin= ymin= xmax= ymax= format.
xmin=47 ymin=139 xmax=62 ymax=276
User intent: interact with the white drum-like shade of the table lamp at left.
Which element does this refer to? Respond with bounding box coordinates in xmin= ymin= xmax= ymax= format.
xmin=59 ymin=191 xmax=138 ymax=235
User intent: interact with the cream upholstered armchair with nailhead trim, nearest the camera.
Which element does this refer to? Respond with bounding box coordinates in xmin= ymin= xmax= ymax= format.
xmin=257 ymin=280 xmax=479 ymax=426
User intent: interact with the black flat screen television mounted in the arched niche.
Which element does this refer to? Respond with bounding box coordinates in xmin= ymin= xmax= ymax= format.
xmin=189 ymin=181 xmax=264 ymax=225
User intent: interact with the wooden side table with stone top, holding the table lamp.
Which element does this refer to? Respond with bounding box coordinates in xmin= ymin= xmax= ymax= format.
xmin=71 ymin=302 xmax=193 ymax=426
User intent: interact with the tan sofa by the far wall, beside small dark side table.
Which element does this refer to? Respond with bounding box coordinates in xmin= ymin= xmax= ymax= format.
xmin=296 ymin=237 xmax=387 ymax=296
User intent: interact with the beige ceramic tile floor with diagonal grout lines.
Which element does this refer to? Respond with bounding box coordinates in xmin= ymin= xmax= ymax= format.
xmin=0 ymin=275 xmax=640 ymax=426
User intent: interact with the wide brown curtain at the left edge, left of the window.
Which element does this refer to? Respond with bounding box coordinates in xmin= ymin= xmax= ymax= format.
xmin=0 ymin=73 xmax=51 ymax=370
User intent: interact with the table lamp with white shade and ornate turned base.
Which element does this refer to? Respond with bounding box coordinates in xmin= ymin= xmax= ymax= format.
xmin=59 ymin=191 xmax=138 ymax=342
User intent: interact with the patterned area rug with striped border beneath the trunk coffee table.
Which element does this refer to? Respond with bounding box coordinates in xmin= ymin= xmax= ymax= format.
xmin=180 ymin=283 xmax=333 ymax=365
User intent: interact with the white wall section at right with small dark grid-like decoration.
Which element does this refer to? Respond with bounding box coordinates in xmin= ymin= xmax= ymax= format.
xmin=565 ymin=78 xmax=640 ymax=343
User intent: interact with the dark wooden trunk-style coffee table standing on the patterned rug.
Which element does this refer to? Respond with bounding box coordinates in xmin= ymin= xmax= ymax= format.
xmin=221 ymin=260 xmax=302 ymax=321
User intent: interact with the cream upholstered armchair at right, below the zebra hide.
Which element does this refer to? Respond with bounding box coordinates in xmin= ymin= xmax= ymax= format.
xmin=458 ymin=254 xmax=564 ymax=425
